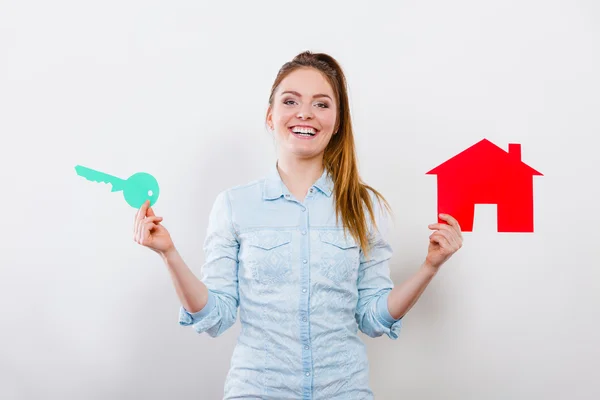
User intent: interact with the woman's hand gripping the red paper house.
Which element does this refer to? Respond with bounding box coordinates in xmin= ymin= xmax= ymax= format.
xmin=425 ymin=214 xmax=463 ymax=269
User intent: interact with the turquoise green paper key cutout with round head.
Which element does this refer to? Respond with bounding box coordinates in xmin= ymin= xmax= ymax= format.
xmin=75 ymin=165 xmax=159 ymax=208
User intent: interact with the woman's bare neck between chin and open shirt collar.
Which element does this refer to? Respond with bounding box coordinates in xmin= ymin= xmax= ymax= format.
xmin=277 ymin=156 xmax=323 ymax=201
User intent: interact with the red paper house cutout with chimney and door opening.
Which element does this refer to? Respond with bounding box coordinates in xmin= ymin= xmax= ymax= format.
xmin=427 ymin=139 xmax=542 ymax=232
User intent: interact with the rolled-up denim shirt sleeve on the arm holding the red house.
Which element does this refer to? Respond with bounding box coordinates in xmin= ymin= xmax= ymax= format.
xmin=355 ymin=195 xmax=402 ymax=340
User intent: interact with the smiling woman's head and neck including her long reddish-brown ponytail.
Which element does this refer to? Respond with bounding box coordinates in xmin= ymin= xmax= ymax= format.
xmin=266 ymin=52 xmax=389 ymax=251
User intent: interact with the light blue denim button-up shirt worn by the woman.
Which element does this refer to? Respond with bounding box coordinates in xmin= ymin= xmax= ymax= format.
xmin=179 ymin=166 xmax=401 ymax=400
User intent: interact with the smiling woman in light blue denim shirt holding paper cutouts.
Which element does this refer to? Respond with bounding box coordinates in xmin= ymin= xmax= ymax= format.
xmin=134 ymin=52 xmax=462 ymax=400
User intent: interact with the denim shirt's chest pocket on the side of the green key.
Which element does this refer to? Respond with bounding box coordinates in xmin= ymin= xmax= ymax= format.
xmin=246 ymin=231 xmax=292 ymax=284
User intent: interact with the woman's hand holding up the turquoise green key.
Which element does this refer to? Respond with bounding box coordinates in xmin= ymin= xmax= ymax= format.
xmin=133 ymin=200 xmax=175 ymax=254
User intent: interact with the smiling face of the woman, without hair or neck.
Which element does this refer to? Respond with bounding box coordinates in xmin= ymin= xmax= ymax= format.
xmin=267 ymin=68 xmax=338 ymax=162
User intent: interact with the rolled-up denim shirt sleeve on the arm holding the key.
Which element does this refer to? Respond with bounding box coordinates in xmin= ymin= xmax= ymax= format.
xmin=179 ymin=192 xmax=239 ymax=337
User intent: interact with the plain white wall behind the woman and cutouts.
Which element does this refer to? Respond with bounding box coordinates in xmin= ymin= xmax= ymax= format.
xmin=0 ymin=0 xmax=600 ymax=400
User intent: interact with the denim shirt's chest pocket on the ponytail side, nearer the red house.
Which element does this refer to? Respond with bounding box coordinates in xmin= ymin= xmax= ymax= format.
xmin=319 ymin=230 xmax=360 ymax=283
